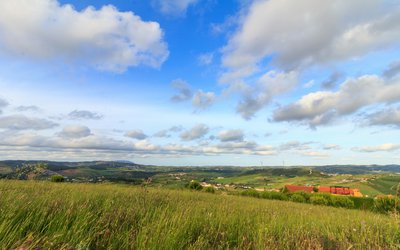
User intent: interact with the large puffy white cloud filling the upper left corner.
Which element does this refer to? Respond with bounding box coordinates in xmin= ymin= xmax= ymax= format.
xmin=0 ymin=0 xmax=169 ymax=72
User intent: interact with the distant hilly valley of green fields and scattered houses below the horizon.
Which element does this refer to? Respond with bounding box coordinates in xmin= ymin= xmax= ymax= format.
xmin=0 ymin=161 xmax=400 ymax=197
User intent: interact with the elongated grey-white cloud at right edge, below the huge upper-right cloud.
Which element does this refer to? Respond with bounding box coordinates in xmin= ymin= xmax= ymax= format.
xmin=273 ymin=75 xmax=400 ymax=127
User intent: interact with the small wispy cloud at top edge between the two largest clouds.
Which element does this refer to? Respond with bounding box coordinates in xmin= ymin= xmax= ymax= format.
xmin=152 ymin=0 xmax=198 ymax=16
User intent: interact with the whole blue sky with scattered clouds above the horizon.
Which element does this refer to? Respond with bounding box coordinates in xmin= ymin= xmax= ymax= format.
xmin=0 ymin=0 xmax=400 ymax=166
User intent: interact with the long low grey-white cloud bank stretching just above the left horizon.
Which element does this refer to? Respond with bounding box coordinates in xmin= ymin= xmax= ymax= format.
xmin=0 ymin=132 xmax=276 ymax=159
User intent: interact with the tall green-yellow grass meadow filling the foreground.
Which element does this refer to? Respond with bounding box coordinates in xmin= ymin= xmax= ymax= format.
xmin=0 ymin=181 xmax=400 ymax=249
